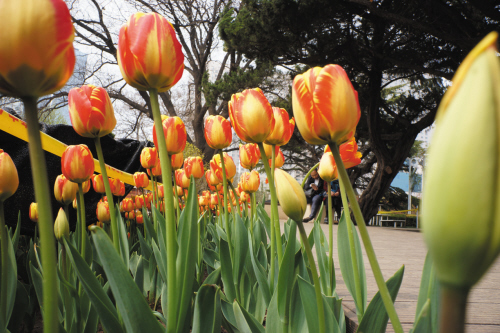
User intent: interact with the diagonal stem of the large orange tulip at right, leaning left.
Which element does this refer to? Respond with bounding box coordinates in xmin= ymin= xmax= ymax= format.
xmin=328 ymin=143 xmax=404 ymax=333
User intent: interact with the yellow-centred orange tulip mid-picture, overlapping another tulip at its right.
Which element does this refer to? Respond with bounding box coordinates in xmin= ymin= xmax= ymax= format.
xmin=228 ymin=88 xmax=274 ymax=143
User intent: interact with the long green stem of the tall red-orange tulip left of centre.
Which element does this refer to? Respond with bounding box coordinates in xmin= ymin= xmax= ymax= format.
xmin=149 ymin=89 xmax=178 ymax=333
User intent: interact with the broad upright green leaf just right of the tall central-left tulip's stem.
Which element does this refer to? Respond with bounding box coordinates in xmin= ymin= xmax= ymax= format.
xmin=176 ymin=175 xmax=199 ymax=332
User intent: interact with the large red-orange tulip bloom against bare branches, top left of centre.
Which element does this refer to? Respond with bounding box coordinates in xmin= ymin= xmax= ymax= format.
xmin=117 ymin=13 xmax=184 ymax=92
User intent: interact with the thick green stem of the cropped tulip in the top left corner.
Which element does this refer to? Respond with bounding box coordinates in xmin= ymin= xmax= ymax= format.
xmin=22 ymin=97 xmax=59 ymax=333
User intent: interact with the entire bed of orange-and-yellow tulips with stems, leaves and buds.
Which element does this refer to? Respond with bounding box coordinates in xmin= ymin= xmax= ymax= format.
xmin=0 ymin=0 xmax=500 ymax=333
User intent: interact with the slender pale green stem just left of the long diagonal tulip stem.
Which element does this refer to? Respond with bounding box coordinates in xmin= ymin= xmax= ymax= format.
xmin=339 ymin=179 xmax=365 ymax=323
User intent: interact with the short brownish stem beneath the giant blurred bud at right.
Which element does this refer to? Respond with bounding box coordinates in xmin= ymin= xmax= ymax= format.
xmin=439 ymin=285 xmax=469 ymax=333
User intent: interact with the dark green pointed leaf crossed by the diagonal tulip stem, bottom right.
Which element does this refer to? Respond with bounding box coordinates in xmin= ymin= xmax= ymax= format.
xmin=358 ymin=265 xmax=405 ymax=333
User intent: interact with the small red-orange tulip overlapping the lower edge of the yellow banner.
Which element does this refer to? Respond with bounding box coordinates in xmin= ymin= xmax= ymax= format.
xmin=61 ymin=145 xmax=94 ymax=183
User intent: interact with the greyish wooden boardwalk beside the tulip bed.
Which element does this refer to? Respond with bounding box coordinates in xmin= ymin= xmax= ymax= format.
xmin=294 ymin=222 xmax=500 ymax=333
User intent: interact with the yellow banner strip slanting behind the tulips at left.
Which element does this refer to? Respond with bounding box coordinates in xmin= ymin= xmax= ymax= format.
xmin=0 ymin=109 xmax=152 ymax=191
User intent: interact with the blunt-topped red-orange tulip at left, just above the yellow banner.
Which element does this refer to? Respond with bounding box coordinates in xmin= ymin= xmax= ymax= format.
xmin=68 ymin=84 xmax=116 ymax=138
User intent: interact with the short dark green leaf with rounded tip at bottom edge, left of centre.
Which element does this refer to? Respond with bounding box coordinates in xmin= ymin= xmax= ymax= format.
xmin=193 ymin=284 xmax=222 ymax=333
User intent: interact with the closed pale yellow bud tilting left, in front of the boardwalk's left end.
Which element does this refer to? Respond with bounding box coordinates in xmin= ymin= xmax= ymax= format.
xmin=274 ymin=169 xmax=307 ymax=222
